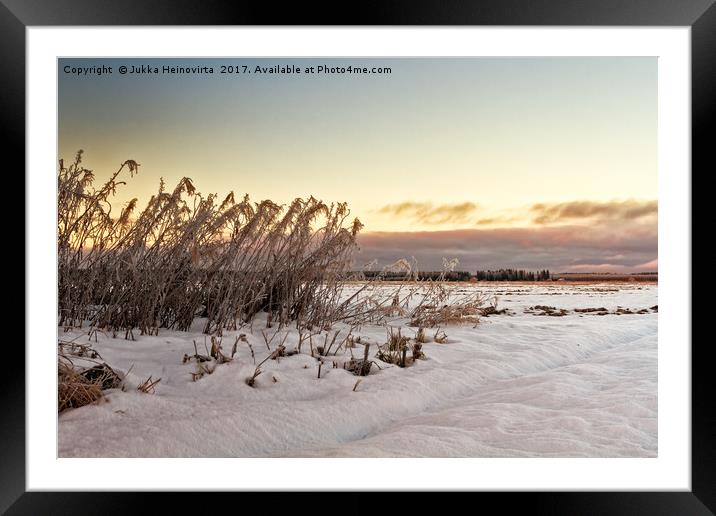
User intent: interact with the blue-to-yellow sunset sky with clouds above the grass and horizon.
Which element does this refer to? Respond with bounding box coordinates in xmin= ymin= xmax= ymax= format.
xmin=58 ymin=57 xmax=657 ymax=271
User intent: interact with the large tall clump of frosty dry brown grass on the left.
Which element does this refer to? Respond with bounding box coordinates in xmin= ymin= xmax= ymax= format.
xmin=57 ymin=151 xmax=362 ymax=338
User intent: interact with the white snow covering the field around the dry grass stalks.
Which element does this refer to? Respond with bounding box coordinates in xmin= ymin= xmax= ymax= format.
xmin=59 ymin=283 xmax=658 ymax=457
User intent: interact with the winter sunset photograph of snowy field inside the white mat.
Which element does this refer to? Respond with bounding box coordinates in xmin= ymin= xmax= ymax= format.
xmin=58 ymin=57 xmax=666 ymax=458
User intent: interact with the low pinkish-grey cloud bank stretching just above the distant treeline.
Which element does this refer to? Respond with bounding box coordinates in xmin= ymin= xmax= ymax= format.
xmin=355 ymin=223 xmax=657 ymax=272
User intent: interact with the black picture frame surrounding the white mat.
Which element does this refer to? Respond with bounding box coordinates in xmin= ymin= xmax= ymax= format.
xmin=5 ymin=0 xmax=716 ymax=515
